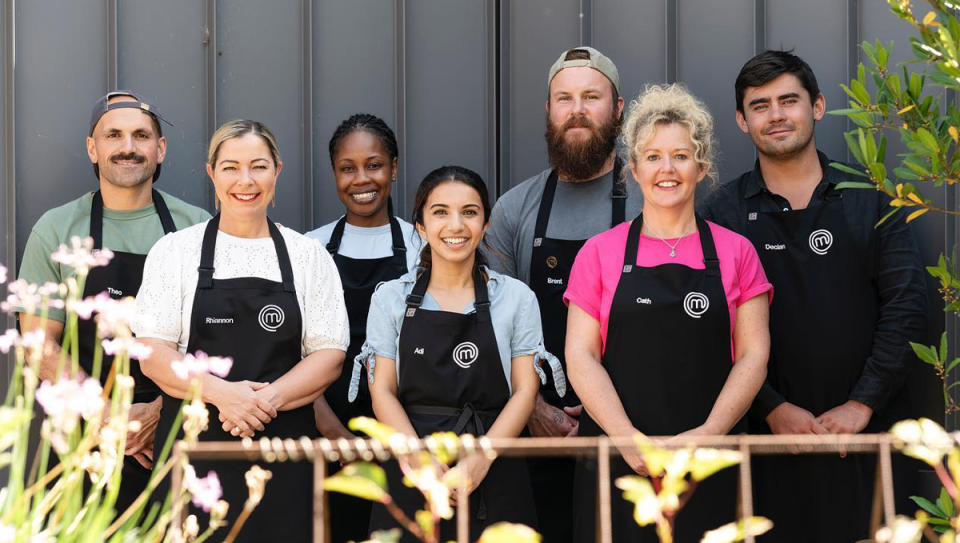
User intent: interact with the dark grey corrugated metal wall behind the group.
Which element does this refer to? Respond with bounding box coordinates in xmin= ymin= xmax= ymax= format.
xmin=0 ymin=0 xmax=956 ymax=424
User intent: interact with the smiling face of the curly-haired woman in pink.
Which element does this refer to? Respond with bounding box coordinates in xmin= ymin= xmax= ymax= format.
xmin=630 ymin=123 xmax=707 ymax=215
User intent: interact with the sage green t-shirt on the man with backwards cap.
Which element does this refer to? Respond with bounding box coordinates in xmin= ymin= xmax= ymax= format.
xmin=19 ymin=191 xmax=210 ymax=322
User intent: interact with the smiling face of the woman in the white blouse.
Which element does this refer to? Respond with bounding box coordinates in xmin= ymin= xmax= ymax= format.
xmin=207 ymin=133 xmax=283 ymax=220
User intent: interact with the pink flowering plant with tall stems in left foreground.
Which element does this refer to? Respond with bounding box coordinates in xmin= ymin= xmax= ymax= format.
xmin=0 ymin=238 xmax=265 ymax=543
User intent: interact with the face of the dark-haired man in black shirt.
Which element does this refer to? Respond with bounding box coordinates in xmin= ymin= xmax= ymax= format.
xmin=737 ymin=73 xmax=826 ymax=160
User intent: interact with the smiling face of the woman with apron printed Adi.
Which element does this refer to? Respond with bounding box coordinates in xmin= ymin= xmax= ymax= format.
xmin=416 ymin=181 xmax=487 ymax=264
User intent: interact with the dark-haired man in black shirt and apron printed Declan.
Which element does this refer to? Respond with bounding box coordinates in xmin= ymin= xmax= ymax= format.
xmin=706 ymin=51 xmax=926 ymax=543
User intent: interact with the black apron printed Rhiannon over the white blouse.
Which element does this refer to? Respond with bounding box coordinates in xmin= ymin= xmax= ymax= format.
xmin=157 ymin=215 xmax=317 ymax=542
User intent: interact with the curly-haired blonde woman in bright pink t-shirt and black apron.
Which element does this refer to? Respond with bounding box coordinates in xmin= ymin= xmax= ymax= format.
xmin=564 ymin=85 xmax=773 ymax=542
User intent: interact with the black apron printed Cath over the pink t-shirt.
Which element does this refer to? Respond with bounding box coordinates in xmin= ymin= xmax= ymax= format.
xmin=574 ymin=214 xmax=746 ymax=543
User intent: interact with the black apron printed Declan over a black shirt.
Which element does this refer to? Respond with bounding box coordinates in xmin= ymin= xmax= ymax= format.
xmin=743 ymin=186 xmax=887 ymax=543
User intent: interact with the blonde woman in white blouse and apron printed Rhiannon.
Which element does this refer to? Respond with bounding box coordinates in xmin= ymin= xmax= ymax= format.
xmin=136 ymin=120 xmax=349 ymax=541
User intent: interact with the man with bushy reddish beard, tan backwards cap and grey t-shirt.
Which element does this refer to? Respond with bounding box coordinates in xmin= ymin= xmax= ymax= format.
xmin=486 ymin=47 xmax=640 ymax=543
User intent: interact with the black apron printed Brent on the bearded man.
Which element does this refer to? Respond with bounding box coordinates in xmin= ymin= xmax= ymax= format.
xmin=523 ymin=158 xmax=627 ymax=543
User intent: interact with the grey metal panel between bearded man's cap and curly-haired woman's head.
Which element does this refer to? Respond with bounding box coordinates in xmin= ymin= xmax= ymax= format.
xmin=588 ymin=0 xmax=667 ymax=105
